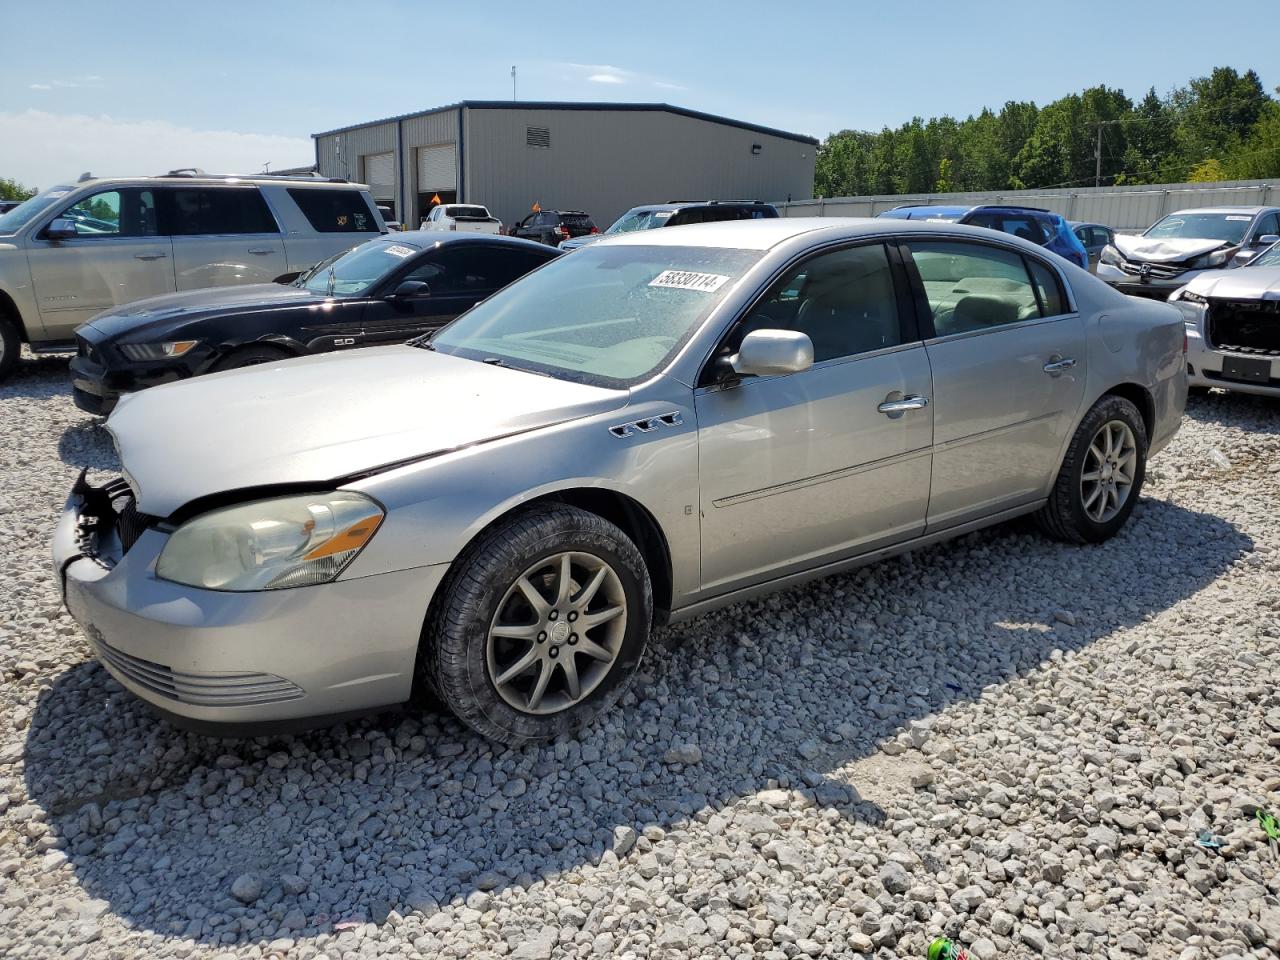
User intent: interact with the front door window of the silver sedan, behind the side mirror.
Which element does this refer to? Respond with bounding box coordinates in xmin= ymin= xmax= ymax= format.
xmin=733 ymin=243 xmax=902 ymax=362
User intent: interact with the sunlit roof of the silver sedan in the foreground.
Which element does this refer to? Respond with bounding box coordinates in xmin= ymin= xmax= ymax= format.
xmin=585 ymin=216 xmax=1059 ymax=252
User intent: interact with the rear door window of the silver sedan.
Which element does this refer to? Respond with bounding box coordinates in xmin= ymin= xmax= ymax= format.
xmin=909 ymin=241 xmax=1044 ymax=337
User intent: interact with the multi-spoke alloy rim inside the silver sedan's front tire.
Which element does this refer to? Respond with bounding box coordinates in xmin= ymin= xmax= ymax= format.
xmin=485 ymin=552 xmax=627 ymax=716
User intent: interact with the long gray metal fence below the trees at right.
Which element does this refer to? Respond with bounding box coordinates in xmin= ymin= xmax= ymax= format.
xmin=773 ymin=180 xmax=1280 ymax=233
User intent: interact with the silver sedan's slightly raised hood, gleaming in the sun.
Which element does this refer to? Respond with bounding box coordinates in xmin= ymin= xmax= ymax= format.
xmin=106 ymin=346 xmax=628 ymax=517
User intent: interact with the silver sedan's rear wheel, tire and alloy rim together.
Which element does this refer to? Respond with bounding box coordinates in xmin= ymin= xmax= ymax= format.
xmin=1036 ymin=394 xmax=1147 ymax=544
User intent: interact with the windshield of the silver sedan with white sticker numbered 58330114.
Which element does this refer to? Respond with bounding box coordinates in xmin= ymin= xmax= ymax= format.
xmin=431 ymin=243 xmax=762 ymax=387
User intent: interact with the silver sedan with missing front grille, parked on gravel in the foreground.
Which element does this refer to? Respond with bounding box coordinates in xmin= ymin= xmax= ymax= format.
xmin=54 ymin=219 xmax=1187 ymax=742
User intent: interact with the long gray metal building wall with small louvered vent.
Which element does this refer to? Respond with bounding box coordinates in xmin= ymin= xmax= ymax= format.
xmin=463 ymin=109 xmax=815 ymax=229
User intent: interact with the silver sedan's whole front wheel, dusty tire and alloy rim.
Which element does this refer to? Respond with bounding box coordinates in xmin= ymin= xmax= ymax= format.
xmin=419 ymin=504 xmax=653 ymax=744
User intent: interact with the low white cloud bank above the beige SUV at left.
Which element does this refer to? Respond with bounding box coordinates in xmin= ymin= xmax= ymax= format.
xmin=0 ymin=110 xmax=315 ymax=189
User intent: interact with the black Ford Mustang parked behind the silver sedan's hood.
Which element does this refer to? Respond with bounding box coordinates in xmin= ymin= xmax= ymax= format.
xmin=72 ymin=230 xmax=559 ymax=415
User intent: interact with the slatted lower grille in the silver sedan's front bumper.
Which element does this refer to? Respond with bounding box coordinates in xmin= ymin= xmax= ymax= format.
xmin=88 ymin=627 xmax=305 ymax=707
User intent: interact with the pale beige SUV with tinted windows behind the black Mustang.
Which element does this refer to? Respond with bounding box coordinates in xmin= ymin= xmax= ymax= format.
xmin=0 ymin=170 xmax=387 ymax=379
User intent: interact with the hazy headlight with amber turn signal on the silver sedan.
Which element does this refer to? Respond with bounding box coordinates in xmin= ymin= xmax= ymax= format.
xmin=156 ymin=490 xmax=384 ymax=590
